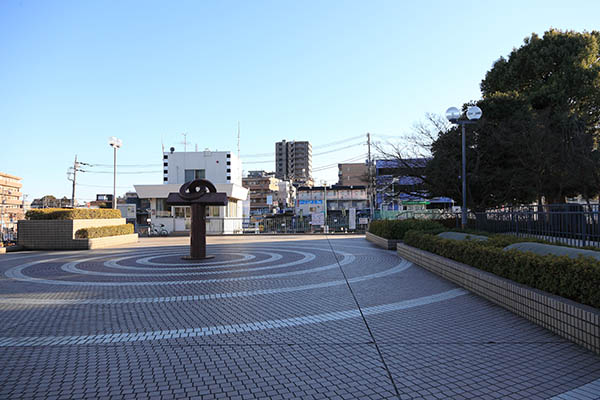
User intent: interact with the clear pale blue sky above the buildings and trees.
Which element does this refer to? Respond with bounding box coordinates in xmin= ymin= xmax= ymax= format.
xmin=0 ymin=0 xmax=600 ymax=200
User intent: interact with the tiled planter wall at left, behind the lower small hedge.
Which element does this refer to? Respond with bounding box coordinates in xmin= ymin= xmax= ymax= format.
xmin=18 ymin=218 xmax=125 ymax=250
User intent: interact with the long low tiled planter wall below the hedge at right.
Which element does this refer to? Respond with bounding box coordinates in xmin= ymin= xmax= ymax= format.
xmin=397 ymin=243 xmax=600 ymax=354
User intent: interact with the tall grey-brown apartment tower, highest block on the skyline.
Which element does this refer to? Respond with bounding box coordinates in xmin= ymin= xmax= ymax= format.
xmin=275 ymin=140 xmax=313 ymax=186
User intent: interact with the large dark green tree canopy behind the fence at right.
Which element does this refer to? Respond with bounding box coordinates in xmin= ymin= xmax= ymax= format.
xmin=426 ymin=30 xmax=600 ymax=209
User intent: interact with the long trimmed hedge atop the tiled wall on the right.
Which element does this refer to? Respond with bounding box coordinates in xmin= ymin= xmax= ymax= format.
xmin=404 ymin=230 xmax=600 ymax=308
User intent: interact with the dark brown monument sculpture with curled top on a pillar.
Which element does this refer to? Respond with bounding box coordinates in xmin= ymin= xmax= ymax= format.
xmin=167 ymin=179 xmax=227 ymax=260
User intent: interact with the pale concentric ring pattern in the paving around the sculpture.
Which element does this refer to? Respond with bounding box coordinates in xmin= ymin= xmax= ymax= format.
xmin=0 ymin=245 xmax=465 ymax=346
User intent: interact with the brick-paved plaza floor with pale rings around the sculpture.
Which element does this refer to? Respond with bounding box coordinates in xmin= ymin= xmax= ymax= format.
xmin=0 ymin=236 xmax=600 ymax=399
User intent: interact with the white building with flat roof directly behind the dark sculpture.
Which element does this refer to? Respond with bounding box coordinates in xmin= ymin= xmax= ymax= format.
xmin=134 ymin=150 xmax=248 ymax=234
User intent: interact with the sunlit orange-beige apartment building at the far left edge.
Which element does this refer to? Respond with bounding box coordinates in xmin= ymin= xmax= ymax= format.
xmin=0 ymin=172 xmax=25 ymax=240
